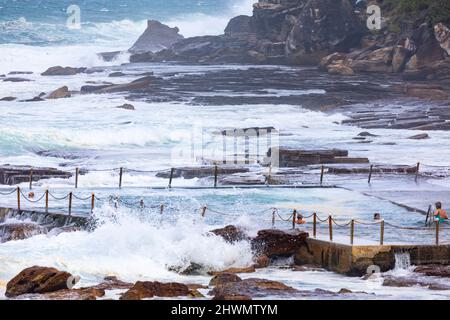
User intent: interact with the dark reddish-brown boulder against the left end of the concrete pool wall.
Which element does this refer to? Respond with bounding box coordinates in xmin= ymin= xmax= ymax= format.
xmin=251 ymin=229 xmax=309 ymax=258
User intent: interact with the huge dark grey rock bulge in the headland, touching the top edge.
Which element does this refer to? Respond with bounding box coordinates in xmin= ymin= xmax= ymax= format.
xmin=286 ymin=0 xmax=365 ymax=64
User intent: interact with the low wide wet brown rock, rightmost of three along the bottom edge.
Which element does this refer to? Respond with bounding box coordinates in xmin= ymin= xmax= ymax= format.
xmin=209 ymin=278 xmax=298 ymax=300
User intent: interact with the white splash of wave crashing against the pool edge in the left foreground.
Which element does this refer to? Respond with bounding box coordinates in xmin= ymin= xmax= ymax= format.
xmin=0 ymin=202 xmax=253 ymax=281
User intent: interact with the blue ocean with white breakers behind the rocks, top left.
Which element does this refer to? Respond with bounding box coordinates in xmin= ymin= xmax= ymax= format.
xmin=0 ymin=0 xmax=253 ymax=74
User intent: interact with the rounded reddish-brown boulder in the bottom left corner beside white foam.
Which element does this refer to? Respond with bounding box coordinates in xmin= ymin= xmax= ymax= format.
xmin=5 ymin=266 xmax=72 ymax=298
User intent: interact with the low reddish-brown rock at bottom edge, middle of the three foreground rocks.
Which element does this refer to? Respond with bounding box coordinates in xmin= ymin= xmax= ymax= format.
xmin=120 ymin=281 xmax=190 ymax=300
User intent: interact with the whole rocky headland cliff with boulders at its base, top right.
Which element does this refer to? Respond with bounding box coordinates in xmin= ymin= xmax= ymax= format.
xmin=132 ymin=0 xmax=450 ymax=79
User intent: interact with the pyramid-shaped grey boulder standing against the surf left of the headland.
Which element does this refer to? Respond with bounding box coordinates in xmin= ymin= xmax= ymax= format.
xmin=129 ymin=20 xmax=184 ymax=53
